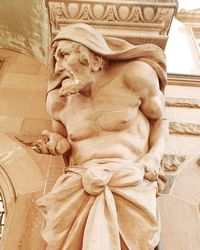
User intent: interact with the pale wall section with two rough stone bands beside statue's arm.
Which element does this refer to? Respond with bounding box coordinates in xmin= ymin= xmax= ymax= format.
xmin=162 ymin=76 xmax=200 ymax=176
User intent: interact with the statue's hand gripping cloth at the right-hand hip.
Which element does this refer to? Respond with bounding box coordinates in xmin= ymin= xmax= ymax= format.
xmin=140 ymin=153 xmax=160 ymax=182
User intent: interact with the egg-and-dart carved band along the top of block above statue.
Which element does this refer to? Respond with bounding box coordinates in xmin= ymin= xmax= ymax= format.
xmin=48 ymin=0 xmax=176 ymax=34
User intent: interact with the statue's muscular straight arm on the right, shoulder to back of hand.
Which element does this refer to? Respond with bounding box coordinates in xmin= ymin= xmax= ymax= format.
xmin=126 ymin=62 xmax=169 ymax=173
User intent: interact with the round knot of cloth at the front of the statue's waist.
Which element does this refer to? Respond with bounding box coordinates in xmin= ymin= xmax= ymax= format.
xmin=82 ymin=169 xmax=112 ymax=196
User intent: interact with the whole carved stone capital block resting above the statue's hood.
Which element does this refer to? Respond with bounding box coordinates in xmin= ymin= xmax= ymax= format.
xmin=46 ymin=0 xmax=177 ymax=48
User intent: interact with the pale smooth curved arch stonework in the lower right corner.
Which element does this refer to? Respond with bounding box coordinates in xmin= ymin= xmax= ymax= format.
xmin=158 ymin=154 xmax=200 ymax=250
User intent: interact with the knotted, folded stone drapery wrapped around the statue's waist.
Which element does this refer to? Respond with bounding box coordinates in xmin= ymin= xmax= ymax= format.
xmin=37 ymin=161 xmax=159 ymax=250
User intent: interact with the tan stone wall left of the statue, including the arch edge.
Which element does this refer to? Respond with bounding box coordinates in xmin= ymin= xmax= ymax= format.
xmin=0 ymin=49 xmax=64 ymax=250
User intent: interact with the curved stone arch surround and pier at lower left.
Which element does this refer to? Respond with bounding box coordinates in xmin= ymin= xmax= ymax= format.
xmin=0 ymin=133 xmax=44 ymax=249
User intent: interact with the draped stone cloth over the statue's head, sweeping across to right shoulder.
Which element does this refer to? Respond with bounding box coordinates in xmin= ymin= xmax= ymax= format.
xmin=48 ymin=23 xmax=167 ymax=92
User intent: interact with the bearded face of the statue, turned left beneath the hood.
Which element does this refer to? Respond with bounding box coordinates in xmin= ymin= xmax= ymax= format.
xmin=54 ymin=41 xmax=92 ymax=95
